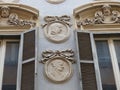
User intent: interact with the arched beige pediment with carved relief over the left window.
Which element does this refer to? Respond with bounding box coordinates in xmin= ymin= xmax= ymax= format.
xmin=0 ymin=4 xmax=39 ymax=29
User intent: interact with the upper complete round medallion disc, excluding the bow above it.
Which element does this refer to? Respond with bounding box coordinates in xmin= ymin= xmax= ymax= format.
xmin=45 ymin=22 xmax=70 ymax=43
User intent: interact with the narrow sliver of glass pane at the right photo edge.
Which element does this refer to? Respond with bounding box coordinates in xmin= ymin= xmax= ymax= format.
xmin=114 ymin=40 xmax=120 ymax=69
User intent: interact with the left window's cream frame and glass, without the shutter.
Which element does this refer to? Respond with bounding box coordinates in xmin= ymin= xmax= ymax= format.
xmin=0 ymin=39 xmax=19 ymax=90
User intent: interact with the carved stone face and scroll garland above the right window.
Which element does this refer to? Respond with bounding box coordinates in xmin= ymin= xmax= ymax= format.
xmin=77 ymin=4 xmax=120 ymax=27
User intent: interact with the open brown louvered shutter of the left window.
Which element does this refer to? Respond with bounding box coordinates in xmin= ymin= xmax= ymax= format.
xmin=20 ymin=29 xmax=36 ymax=90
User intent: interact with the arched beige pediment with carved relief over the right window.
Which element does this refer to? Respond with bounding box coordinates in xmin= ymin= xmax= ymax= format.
xmin=74 ymin=2 xmax=120 ymax=29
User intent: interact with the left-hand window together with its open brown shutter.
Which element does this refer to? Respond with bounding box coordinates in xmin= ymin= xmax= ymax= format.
xmin=0 ymin=29 xmax=38 ymax=90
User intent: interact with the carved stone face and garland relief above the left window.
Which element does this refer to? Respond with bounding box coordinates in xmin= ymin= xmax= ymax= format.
xmin=0 ymin=6 xmax=36 ymax=27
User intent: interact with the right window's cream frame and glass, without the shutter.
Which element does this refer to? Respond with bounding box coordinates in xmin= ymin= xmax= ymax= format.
xmin=95 ymin=37 xmax=120 ymax=90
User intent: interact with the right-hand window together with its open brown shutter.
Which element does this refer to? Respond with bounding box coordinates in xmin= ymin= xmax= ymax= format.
xmin=75 ymin=31 xmax=120 ymax=90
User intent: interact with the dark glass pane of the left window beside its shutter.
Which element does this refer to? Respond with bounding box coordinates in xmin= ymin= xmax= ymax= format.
xmin=2 ymin=42 xmax=19 ymax=90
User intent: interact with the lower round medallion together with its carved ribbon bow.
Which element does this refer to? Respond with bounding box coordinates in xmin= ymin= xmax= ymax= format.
xmin=41 ymin=50 xmax=75 ymax=83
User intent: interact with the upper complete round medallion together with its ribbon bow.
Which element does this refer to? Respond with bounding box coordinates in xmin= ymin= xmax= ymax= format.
xmin=42 ymin=15 xmax=71 ymax=43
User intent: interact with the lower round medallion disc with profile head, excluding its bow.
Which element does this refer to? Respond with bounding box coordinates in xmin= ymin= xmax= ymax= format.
xmin=45 ymin=57 xmax=73 ymax=83
